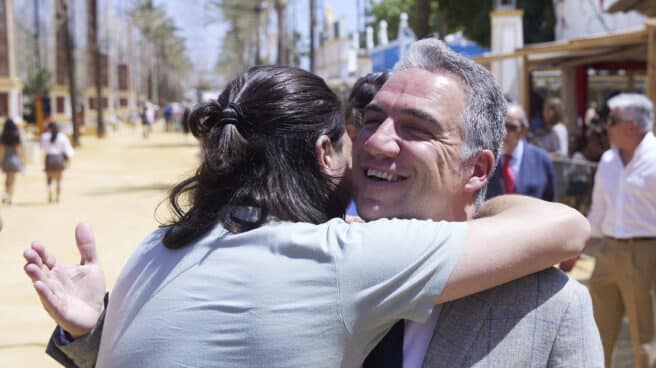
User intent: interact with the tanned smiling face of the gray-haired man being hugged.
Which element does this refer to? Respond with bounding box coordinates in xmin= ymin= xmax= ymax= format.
xmin=353 ymin=69 xmax=471 ymax=220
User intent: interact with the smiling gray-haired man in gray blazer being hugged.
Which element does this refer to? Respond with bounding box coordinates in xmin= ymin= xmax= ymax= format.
xmin=362 ymin=39 xmax=604 ymax=368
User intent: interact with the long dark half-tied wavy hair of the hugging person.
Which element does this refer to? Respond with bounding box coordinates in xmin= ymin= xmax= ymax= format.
xmin=163 ymin=66 xmax=350 ymax=249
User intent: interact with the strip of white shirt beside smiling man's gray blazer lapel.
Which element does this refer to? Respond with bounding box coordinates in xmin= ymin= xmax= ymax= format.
xmin=403 ymin=304 xmax=442 ymax=368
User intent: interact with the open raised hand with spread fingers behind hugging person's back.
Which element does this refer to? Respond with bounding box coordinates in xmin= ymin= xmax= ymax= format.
xmin=23 ymin=223 xmax=106 ymax=337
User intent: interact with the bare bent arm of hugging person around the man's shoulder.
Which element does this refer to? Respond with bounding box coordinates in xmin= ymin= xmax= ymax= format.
xmin=437 ymin=195 xmax=590 ymax=303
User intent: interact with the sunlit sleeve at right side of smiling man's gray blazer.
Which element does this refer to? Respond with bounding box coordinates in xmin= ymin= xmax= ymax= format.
xmin=547 ymin=282 xmax=604 ymax=368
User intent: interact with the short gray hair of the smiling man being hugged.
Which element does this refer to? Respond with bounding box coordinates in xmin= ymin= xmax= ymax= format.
xmin=394 ymin=38 xmax=506 ymax=206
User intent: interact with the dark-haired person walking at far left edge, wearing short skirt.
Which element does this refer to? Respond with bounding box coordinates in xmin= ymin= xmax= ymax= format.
xmin=0 ymin=119 xmax=25 ymax=206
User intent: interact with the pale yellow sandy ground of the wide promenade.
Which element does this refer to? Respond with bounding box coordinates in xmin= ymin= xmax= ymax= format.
xmin=0 ymin=126 xmax=632 ymax=368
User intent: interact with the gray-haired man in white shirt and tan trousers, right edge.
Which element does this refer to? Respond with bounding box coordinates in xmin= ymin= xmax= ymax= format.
xmin=588 ymin=94 xmax=656 ymax=367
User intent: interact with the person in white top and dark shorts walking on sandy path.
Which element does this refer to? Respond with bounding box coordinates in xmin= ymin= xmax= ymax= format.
xmin=41 ymin=122 xmax=74 ymax=203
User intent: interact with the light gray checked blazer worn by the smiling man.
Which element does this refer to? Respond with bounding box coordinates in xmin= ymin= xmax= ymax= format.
xmin=423 ymin=268 xmax=604 ymax=368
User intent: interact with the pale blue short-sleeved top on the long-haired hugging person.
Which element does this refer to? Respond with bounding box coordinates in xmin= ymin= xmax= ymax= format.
xmin=97 ymin=219 xmax=467 ymax=368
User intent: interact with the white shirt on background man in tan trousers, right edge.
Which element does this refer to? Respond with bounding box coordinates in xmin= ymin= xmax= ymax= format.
xmin=588 ymin=132 xmax=656 ymax=239
